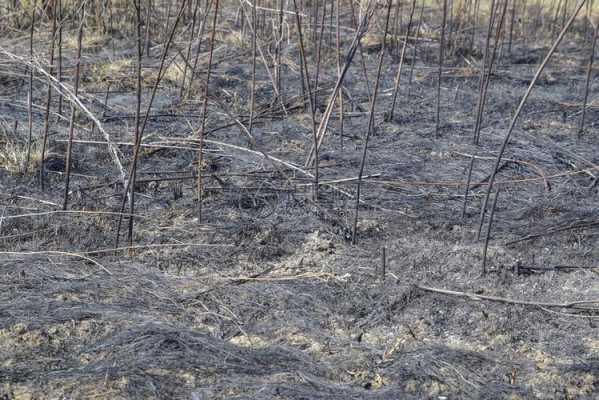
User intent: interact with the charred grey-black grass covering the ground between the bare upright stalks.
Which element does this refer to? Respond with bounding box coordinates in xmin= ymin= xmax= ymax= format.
xmin=0 ymin=6 xmax=599 ymax=399
